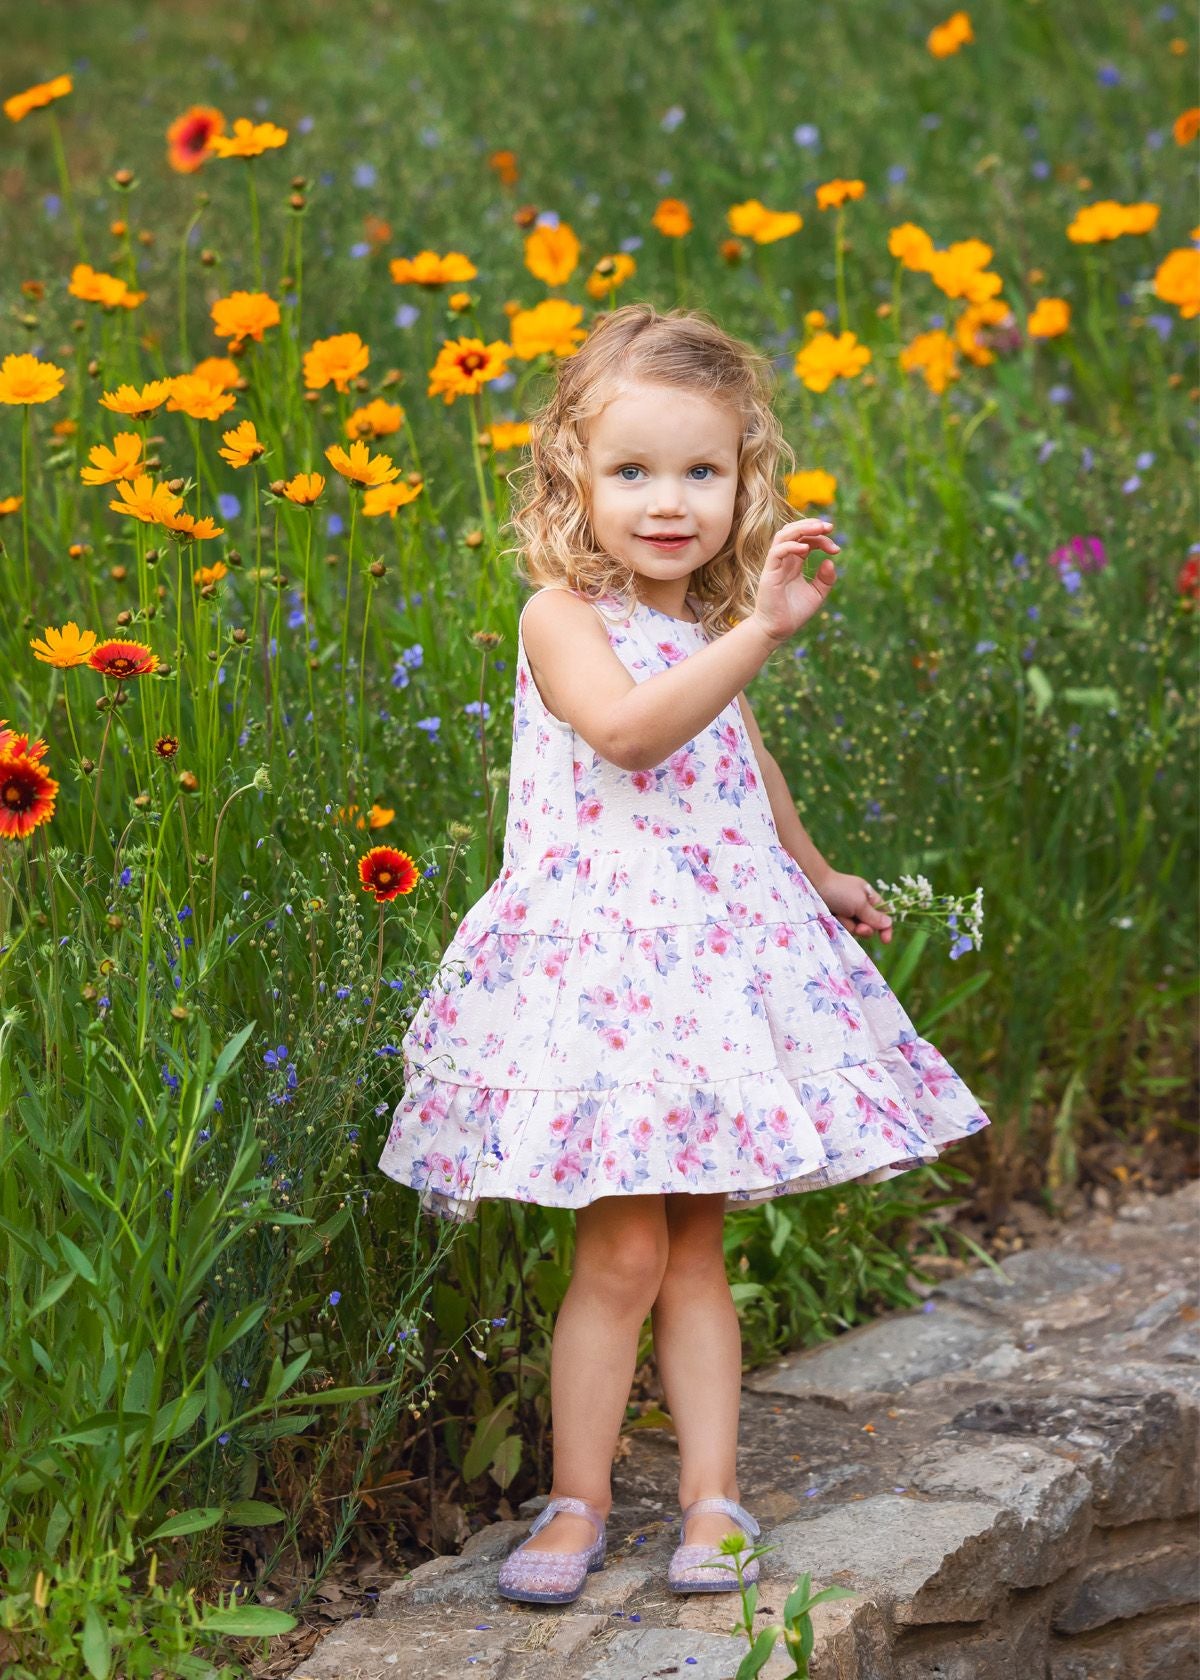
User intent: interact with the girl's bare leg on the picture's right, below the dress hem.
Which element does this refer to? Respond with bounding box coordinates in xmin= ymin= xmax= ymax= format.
xmin=652 ymin=1194 xmax=741 ymax=1546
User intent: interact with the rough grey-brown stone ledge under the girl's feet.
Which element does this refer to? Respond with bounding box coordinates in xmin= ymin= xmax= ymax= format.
xmin=292 ymin=1184 xmax=1200 ymax=1680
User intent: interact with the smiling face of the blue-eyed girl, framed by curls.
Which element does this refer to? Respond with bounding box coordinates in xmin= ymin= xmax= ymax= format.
xmin=587 ymin=383 xmax=741 ymax=606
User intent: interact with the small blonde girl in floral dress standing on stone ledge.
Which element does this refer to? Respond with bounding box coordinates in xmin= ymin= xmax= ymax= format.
xmin=380 ymin=304 xmax=988 ymax=1604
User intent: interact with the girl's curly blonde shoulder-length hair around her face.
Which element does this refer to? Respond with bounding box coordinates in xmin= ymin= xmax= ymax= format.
xmin=506 ymin=302 xmax=797 ymax=635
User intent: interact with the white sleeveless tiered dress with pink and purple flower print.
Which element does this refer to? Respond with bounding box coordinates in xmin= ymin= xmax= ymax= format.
xmin=380 ymin=596 xmax=988 ymax=1220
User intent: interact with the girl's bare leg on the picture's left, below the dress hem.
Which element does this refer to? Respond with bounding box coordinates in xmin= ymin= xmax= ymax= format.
xmin=528 ymin=1196 xmax=667 ymax=1552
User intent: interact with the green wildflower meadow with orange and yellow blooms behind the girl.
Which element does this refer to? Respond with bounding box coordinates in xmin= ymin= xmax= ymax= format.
xmin=0 ymin=0 xmax=1200 ymax=1680
